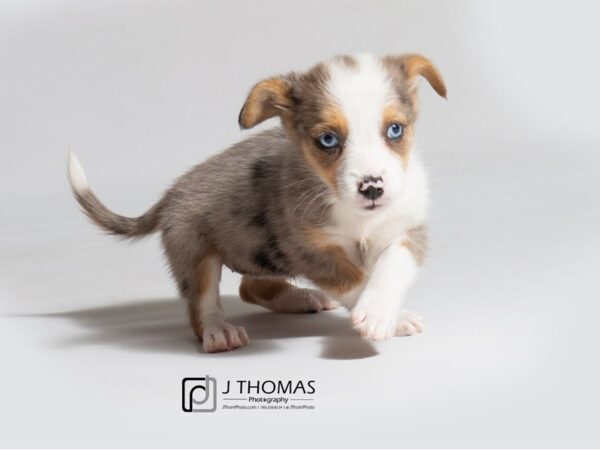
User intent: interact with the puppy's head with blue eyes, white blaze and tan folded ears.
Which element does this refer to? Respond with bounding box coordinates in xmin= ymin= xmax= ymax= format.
xmin=239 ymin=55 xmax=446 ymax=211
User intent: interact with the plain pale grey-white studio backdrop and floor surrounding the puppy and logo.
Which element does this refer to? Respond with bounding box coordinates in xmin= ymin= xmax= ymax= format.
xmin=0 ymin=0 xmax=600 ymax=447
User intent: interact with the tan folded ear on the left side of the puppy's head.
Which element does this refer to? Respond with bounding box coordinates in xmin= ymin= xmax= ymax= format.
xmin=238 ymin=76 xmax=293 ymax=129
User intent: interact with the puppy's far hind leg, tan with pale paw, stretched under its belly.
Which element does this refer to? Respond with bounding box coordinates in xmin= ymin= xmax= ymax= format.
xmin=240 ymin=276 xmax=339 ymax=314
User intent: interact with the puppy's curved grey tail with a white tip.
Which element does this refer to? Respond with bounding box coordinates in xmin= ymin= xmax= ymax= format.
xmin=67 ymin=152 xmax=163 ymax=238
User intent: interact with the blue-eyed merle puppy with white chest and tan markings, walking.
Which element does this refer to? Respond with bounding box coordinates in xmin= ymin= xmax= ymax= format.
xmin=68 ymin=54 xmax=446 ymax=352
